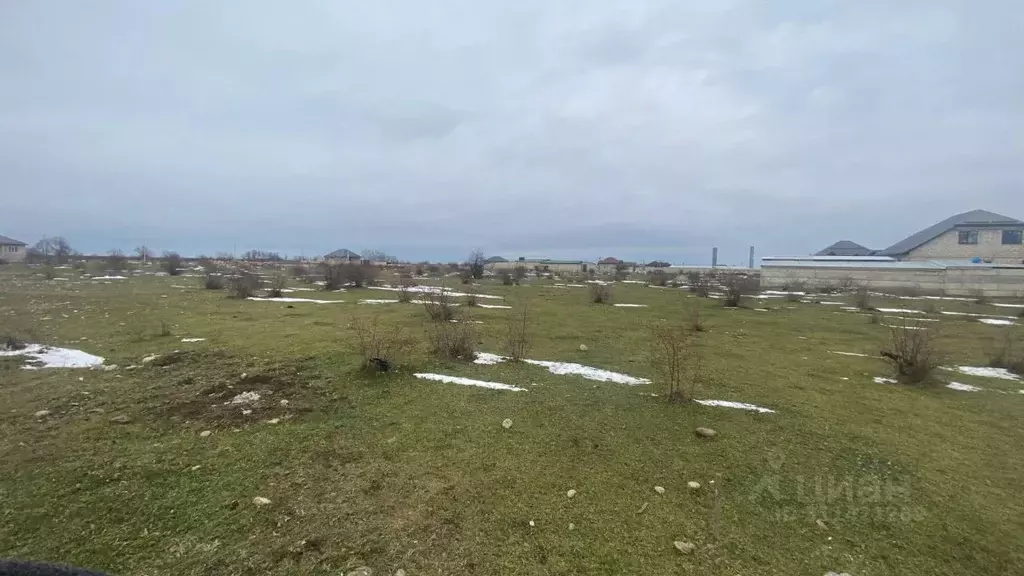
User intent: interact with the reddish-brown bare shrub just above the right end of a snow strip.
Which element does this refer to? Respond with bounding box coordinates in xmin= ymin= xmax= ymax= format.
xmin=650 ymin=324 xmax=703 ymax=402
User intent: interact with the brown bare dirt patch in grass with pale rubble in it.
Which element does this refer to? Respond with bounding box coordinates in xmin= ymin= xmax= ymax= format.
xmin=146 ymin=352 xmax=326 ymax=427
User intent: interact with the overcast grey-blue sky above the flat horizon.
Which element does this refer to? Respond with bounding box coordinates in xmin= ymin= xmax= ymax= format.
xmin=0 ymin=0 xmax=1024 ymax=263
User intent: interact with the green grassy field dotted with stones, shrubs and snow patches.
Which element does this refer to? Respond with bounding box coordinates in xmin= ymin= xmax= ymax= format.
xmin=0 ymin=268 xmax=1024 ymax=576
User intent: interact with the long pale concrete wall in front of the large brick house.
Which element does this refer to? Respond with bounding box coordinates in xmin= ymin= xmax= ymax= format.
xmin=761 ymin=261 xmax=1024 ymax=298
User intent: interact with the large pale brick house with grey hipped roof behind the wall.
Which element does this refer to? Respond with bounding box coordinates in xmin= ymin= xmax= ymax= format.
xmin=874 ymin=210 xmax=1024 ymax=264
